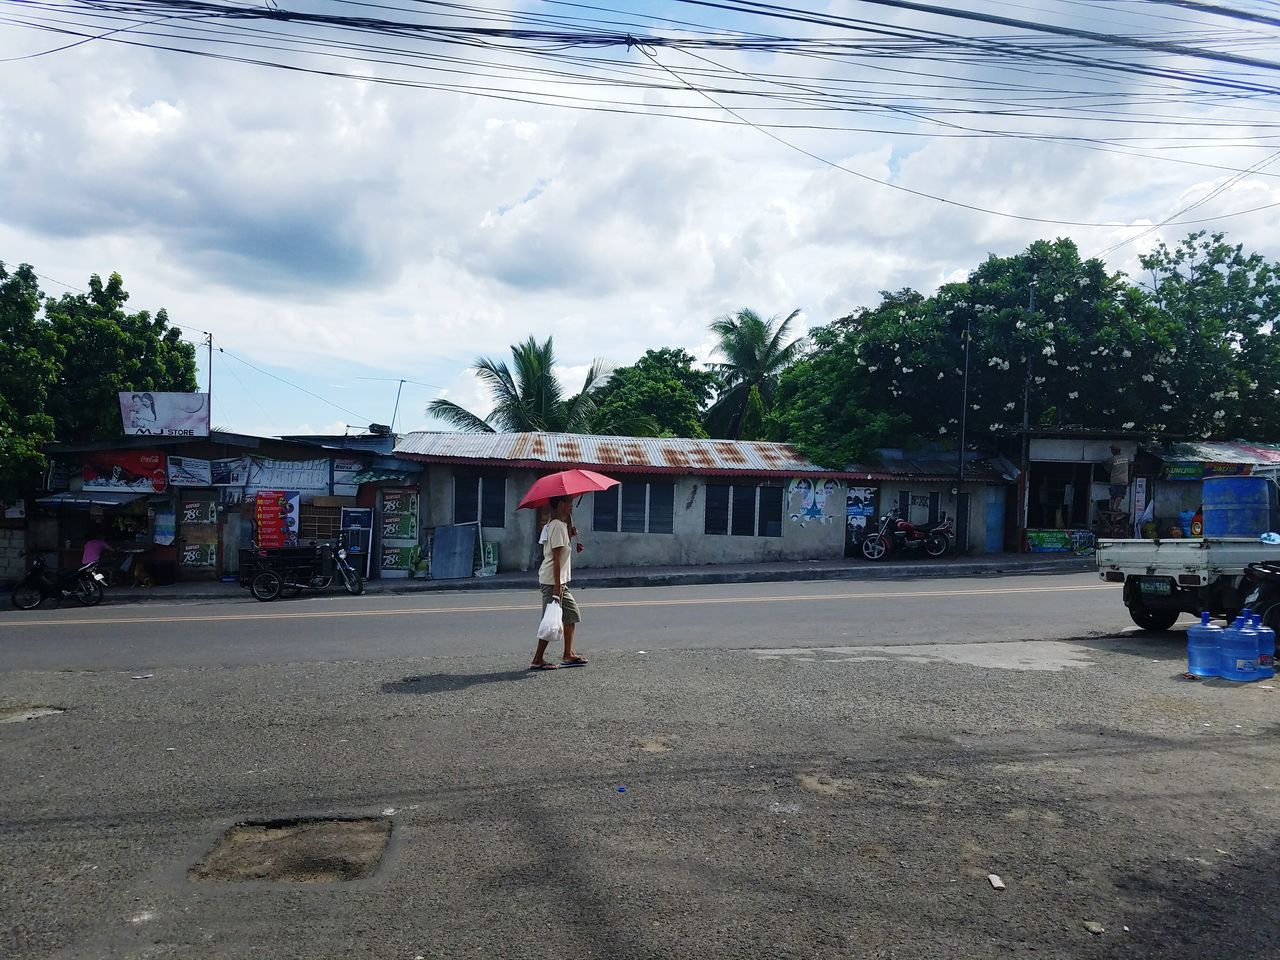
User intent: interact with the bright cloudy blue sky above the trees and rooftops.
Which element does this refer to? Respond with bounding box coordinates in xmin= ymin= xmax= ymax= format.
xmin=0 ymin=0 xmax=1280 ymax=435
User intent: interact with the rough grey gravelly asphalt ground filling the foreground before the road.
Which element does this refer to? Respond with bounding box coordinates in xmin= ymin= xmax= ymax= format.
xmin=0 ymin=637 xmax=1280 ymax=960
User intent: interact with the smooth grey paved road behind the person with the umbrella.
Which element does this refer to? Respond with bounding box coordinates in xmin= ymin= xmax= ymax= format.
xmin=0 ymin=573 xmax=1129 ymax=671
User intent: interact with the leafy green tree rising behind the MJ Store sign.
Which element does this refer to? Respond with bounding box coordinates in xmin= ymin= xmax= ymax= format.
xmin=45 ymin=273 xmax=197 ymax=442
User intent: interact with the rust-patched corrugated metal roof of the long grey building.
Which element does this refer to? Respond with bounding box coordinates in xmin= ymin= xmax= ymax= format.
xmin=394 ymin=431 xmax=849 ymax=476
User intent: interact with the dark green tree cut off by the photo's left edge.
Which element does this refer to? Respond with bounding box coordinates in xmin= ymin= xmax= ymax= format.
xmin=0 ymin=264 xmax=61 ymax=499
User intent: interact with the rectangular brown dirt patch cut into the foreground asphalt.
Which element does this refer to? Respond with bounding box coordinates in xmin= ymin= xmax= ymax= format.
xmin=187 ymin=817 xmax=392 ymax=883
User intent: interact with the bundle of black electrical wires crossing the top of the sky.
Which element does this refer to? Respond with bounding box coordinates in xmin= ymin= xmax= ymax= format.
xmin=0 ymin=0 xmax=1280 ymax=225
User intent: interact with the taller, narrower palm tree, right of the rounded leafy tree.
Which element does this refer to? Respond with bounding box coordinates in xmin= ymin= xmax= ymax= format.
xmin=704 ymin=307 xmax=803 ymax=439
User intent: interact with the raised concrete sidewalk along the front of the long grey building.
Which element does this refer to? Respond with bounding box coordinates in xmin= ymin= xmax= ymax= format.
xmin=85 ymin=553 xmax=1097 ymax=603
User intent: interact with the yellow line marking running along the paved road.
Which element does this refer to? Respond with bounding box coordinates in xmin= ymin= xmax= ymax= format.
xmin=0 ymin=584 xmax=1116 ymax=627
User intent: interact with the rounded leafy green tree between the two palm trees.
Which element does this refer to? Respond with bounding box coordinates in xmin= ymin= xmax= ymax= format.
xmin=595 ymin=347 xmax=717 ymax=438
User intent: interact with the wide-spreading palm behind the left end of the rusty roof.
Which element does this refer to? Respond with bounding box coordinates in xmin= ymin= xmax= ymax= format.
xmin=426 ymin=337 xmax=657 ymax=436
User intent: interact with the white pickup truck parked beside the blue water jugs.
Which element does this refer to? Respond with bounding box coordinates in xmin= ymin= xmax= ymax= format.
xmin=1097 ymin=538 xmax=1280 ymax=630
